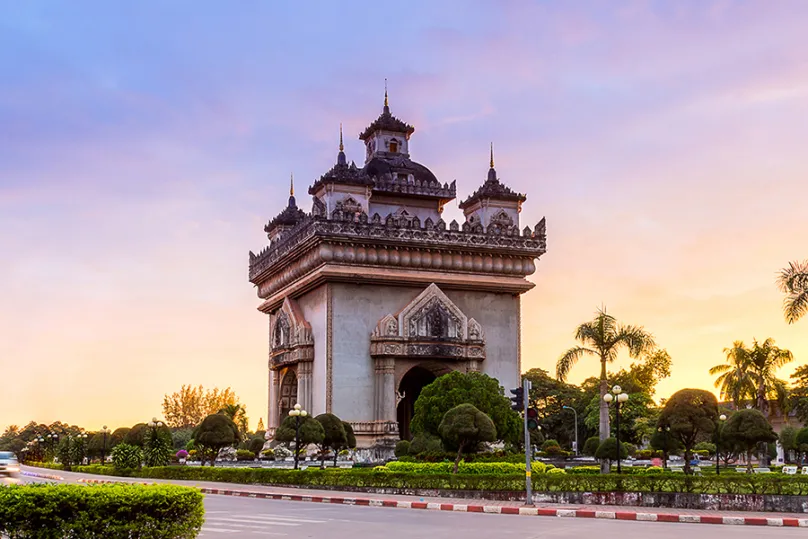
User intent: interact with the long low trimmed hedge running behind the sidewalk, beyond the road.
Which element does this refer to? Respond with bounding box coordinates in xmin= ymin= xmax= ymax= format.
xmin=52 ymin=466 xmax=808 ymax=496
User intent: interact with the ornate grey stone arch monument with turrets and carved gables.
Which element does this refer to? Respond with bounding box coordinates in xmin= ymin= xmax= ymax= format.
xmin=249 ymin=95 xmax=546 ymax=452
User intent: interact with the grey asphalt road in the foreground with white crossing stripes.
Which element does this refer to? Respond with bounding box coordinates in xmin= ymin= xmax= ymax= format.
xmin=7 ymin=470 xmax=805 ymax=539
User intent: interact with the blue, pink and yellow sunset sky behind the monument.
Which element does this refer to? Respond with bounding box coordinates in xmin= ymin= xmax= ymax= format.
xmin=0 ymin=0 xmax=808 ymax=429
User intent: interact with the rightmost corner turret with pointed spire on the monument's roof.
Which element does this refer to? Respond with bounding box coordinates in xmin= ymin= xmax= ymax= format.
xmin=459 ymin=143 xmax=527 ymax=229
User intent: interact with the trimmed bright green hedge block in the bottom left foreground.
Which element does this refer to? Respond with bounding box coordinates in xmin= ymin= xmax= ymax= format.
xmin=0 ymin=484 xmax=205 ymax=539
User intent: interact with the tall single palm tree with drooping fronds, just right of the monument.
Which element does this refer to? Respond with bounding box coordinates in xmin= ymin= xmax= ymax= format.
xmin=556 ymin=307 xmax=656 ymax=448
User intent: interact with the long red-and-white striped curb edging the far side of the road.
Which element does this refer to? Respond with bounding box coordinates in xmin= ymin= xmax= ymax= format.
xmin=196 ymin=488 xmax=808 ymax=528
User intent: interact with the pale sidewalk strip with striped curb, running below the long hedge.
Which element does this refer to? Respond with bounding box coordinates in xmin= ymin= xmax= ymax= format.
xmin=24 ymin=467 xmax=808 ymax=527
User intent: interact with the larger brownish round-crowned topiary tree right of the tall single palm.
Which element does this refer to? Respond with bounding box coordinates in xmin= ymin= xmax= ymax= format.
xmin=659 ymin=389 xmax=718 ymax=473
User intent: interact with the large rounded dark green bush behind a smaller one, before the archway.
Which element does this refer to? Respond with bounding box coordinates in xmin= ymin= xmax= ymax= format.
xmin=411 ymin=371 xmax=521 ymax=443
